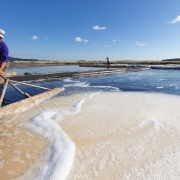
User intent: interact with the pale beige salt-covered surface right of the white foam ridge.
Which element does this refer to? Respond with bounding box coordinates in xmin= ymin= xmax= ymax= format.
xmin=60 ymin=92 xmax=180 ymax=180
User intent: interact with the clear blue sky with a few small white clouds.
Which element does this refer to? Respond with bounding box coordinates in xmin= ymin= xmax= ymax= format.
xmin=0 ymin=0 xmax=180 ymax=61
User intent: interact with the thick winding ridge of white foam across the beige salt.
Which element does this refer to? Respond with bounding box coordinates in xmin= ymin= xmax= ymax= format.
xmin=17 ymin=92 xmax=99 ymax=180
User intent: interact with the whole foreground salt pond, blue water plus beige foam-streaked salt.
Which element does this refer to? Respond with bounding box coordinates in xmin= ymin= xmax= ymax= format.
xmin=0 ymin=70 xmax=180 ymax=180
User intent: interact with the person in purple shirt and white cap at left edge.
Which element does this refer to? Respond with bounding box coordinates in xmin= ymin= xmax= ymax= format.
xmin=0 ymin=29 xmax=9 ymax=74
